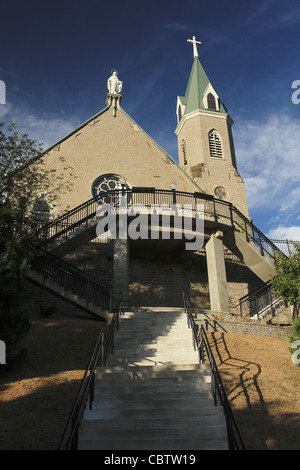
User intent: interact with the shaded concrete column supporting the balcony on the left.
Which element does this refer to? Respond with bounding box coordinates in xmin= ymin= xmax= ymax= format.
xmin=113 ymin=238 xmax=129 ymax=306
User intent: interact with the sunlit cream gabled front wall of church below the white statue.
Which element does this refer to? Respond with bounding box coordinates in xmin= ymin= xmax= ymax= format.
xmin=42 ymin=109 xmax=200 ymax=213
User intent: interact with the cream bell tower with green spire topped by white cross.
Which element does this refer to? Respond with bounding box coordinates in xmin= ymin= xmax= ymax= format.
xmin=175 ymin=36 xmax=248 ymax=217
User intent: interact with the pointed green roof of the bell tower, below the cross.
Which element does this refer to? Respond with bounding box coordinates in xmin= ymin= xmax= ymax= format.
xmin=180 ymin=57 xmax=227 ymax=114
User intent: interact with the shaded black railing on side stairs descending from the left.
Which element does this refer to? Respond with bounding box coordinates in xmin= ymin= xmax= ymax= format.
xmin=27 ymin=241 xmax=111 ymax=310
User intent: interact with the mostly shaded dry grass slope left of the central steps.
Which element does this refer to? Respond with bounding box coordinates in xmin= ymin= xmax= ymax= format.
xmin=0 ymin=317 xmax=101 ymax=450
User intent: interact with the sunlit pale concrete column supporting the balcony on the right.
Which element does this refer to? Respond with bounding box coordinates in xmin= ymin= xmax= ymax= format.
xmin=206 ymin=231 xmax=229 ymax=313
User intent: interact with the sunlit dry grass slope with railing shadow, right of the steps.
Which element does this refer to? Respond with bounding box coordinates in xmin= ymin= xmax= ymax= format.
xmin=209 ymin=333 xmax=300 ymax=450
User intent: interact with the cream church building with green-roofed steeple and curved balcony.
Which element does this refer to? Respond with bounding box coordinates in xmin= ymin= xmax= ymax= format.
xmin=28 ymin=37 xmax=274 ymax=320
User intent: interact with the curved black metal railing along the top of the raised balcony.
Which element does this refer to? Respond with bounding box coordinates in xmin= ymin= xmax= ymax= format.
xmin=29 ymin=188 xmax=280 ymax=258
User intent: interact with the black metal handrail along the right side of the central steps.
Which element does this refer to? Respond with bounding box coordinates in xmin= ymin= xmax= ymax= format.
xmin=183 ymin=292 xmax=245 ymax=450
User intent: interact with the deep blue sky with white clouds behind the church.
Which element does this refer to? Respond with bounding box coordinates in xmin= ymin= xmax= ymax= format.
xmin=0 ymin=0 xmax=300 ymax=240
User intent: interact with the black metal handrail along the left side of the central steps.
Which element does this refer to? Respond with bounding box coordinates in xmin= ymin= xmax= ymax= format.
xmin=58 ymin=293 xmax=124 ymax=450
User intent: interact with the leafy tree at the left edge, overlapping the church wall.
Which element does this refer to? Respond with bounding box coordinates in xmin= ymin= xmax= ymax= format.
xmin=0 ymin=123 xmax=70 ymax=362
